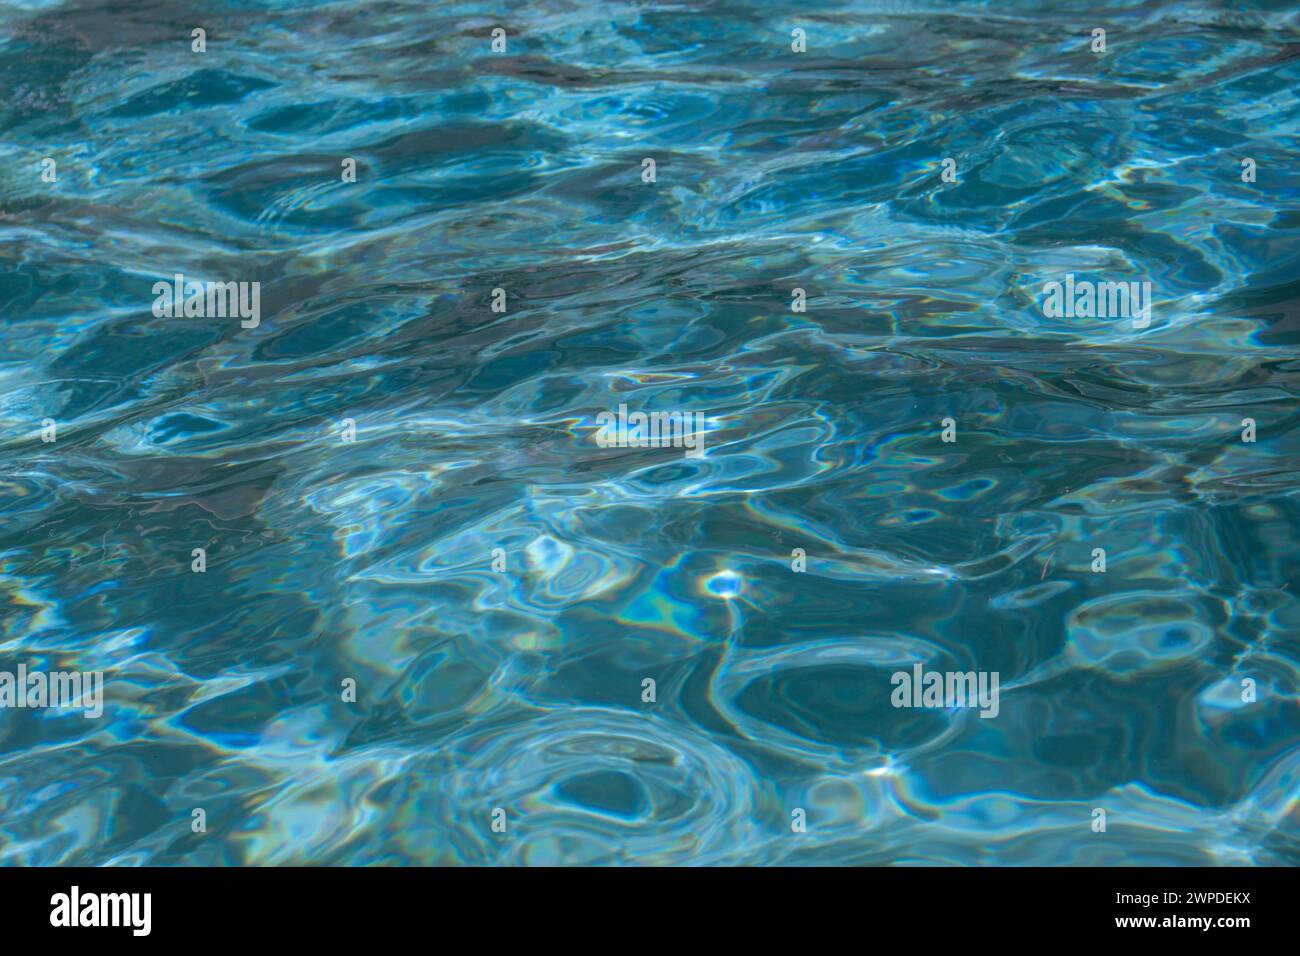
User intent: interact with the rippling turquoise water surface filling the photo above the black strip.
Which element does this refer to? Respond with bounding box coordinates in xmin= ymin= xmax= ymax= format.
xmin=0 ymin=0 xmax=1300 ymax=865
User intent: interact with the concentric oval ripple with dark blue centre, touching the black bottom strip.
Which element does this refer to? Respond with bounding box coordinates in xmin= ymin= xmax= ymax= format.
xmin=412 ymin=708 xmax=766 ymax=865
